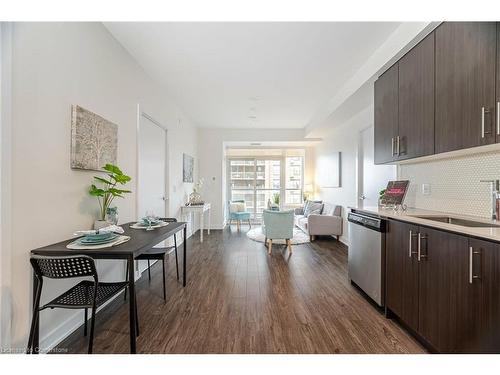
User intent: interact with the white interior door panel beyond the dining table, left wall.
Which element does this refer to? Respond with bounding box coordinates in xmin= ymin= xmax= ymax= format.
xmin=138 ymin=115 xmax=167 ymax=218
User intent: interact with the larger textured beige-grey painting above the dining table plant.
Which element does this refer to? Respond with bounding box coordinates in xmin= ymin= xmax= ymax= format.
xmin=71 ymin=105 xmax=118 ymax=171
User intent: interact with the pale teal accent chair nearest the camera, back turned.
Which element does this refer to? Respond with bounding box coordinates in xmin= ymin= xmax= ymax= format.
xmin=262 ymin=210 xmax=294 ymax=254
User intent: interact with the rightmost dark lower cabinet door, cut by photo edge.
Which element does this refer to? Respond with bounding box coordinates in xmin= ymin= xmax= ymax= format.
xmin=469 ymin=239 xmax=500 ymax=353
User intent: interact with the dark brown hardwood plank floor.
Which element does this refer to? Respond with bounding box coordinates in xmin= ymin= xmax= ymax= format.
xmin=58 ymin=226 xmax=425 ymax=353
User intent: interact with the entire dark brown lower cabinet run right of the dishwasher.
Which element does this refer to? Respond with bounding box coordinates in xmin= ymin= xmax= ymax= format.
xmin=386 ymin=220 xmax=500 ymax=353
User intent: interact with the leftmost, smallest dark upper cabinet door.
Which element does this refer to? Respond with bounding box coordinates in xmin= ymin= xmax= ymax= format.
xmin=374 ymin=64 xmax=398 ymax=164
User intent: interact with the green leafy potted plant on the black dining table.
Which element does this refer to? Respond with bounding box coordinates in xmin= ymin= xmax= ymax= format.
xmin=89 ymin=164 xmax=131 ymax=229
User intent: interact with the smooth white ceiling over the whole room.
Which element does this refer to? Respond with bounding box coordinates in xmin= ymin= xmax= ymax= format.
xmin=105 ymin=22 xmax=400 ymax=128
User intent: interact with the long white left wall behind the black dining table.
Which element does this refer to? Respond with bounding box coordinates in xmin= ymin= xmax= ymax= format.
xmin=2 ymin=23 xmax=197 ymax=347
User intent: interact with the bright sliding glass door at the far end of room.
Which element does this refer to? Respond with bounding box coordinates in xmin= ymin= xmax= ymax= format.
xmin=228 ymin=157 xmax=303 ymax=222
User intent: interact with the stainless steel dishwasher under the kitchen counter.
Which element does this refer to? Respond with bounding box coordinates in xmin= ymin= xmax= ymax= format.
xmin=347 ymin=212 xmax=385 ymax=307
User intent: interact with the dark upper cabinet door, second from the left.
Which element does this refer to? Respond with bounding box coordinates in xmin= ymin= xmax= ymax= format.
xmin=398 ymin=33 xmax=434 ymax=160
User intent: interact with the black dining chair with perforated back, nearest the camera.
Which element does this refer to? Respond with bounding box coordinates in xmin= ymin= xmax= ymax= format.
xmin=26 ymin=255 xmax=132 ymax=354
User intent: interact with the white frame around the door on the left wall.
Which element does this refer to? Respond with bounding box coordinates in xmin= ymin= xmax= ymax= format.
xmin=135 ymin=104 xmax=170 ymax=218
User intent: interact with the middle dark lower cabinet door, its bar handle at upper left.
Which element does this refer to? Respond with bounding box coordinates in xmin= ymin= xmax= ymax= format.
xmin=418 ymin=227 xmax=476 ymax=353
